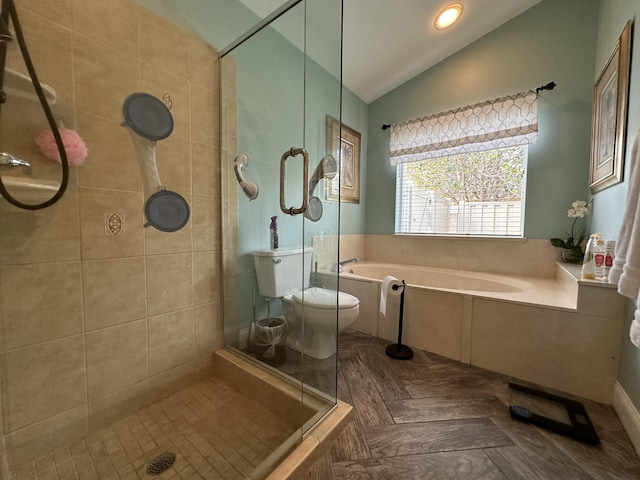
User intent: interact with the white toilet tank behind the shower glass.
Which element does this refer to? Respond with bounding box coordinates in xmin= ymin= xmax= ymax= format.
xmin=253 ymin=247 xmax=313 ymax=298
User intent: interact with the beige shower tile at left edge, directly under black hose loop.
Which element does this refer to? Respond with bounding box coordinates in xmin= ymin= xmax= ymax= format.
xmin=0 ymin=173 xmax=80 ymax=265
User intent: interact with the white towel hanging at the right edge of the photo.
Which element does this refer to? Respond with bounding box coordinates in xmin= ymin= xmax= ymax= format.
xmin=609 ymin=130 xmax=640 ymax=348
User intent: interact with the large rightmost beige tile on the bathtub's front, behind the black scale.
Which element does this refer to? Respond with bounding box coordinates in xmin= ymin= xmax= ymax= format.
xmin=471 ymin=299 xmax=626 ymax=404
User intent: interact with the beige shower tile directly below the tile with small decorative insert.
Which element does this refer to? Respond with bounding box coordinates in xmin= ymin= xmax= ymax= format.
xmin=82 ymin=257 xmax=146 ymax=331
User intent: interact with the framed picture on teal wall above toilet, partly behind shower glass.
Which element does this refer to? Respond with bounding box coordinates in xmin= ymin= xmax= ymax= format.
xmin=326 ymin=115 xmax=360 ymax=203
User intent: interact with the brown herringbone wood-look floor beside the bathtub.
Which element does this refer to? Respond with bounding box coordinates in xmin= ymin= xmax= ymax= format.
xmin=306 ymin=331 xmax=640 ymax=480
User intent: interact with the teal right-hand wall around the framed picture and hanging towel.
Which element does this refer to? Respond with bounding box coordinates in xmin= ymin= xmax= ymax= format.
xmin=592 ymin=0 xmax=640 ymax=410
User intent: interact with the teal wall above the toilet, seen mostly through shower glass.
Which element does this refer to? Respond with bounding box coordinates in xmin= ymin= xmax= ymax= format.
xmin=138 ymin=0 xmax=368 ymax=240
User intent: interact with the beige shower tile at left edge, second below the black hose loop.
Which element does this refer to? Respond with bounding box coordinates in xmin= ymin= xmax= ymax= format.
xmin=0 ymin=262 xmax=82 ymax=350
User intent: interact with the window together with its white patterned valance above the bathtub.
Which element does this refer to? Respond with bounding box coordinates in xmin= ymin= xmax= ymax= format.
xmin=389 ymin=90 xmax=538 ymax=237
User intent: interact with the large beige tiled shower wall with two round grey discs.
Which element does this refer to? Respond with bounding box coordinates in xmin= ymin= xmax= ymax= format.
xmin=0 ymin=0 xmax=222 ymax=463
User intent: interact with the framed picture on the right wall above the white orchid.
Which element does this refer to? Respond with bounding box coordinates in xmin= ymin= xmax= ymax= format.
xmin=589 ymin=21 xmax=633 ymax=193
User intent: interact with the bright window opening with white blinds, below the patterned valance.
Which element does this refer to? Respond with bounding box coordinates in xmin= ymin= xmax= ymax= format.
xmin=395 ymin=146 xmax=527 ymax=237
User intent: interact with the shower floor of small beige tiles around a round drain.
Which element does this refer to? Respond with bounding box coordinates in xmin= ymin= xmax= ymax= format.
xmin=11 ymin=377 xmax=295 ymax=480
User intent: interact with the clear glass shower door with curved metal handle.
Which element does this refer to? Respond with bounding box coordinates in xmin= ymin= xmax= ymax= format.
xmin=221 ymin=0 xmax=342 ymax=436
